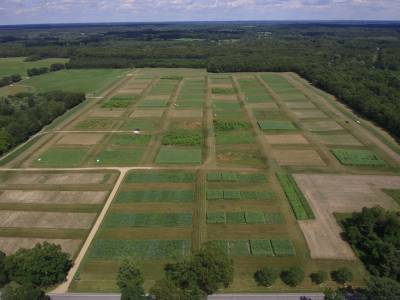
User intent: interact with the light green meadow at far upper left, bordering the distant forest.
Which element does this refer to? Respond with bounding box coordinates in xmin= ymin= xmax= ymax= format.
xmin=0 ymin=57 xmax=68 ymax=78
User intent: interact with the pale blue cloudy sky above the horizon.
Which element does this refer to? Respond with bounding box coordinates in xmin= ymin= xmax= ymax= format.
xmin=0 ymin=0 xmax=400 ymax=25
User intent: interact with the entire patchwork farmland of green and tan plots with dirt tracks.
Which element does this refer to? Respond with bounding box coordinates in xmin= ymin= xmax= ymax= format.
xmin=0 ymin=69 xmax=400 ymax=292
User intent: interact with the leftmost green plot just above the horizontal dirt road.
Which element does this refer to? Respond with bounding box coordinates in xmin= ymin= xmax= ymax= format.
xmin=33 ymin=148 xmax=89 ymax=167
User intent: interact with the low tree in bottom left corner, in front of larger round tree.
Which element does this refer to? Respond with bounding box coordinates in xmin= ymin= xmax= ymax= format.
xmin=1 ymin=282 xmax=50 ymax=300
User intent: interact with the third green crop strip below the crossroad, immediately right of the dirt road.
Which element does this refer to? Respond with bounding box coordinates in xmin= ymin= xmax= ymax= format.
xmin=104 ymin=213 xmax=192 ymax=228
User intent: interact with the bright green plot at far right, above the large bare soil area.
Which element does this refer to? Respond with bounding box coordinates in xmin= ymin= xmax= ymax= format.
xmin=331 ymin=149 xmax=386 ymax=167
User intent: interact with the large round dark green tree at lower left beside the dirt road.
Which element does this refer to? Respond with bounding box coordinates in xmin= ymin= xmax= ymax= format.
xmin=5 ymin=242 xmax=72 ymax=287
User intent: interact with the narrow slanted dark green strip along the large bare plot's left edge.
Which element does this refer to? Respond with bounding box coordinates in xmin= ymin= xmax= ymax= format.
xmin=276 ymin=173 xmax=315 ymax=220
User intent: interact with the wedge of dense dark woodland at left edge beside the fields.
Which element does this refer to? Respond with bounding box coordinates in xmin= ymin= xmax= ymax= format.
xmin=0 ymin=91 xmax=85 ymax=154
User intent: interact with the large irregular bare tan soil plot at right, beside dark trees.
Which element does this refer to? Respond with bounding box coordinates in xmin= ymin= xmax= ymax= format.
xmin=294 ymin=174 xmax=400 ymax=260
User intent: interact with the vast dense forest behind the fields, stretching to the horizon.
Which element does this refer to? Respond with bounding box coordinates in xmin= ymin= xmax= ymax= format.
xmin=0 ymin=22 xmax=400 ymax=138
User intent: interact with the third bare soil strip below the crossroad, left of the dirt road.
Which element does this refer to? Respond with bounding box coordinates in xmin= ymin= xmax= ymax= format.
xmin=0 ymin=210 xmax=96 ymax=229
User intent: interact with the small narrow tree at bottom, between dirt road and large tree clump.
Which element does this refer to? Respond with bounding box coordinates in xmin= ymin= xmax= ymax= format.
xmin=117 ymin=260 xmax=144 ymax=300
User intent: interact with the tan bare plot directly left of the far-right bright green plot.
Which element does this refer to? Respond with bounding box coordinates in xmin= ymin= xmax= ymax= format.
xmin=272 ymin=149 xmax=325 ymax=166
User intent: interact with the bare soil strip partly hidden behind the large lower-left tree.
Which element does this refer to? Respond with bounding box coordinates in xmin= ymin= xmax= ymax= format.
xmin=0 ymin=237 xmax=82 ymax=256
